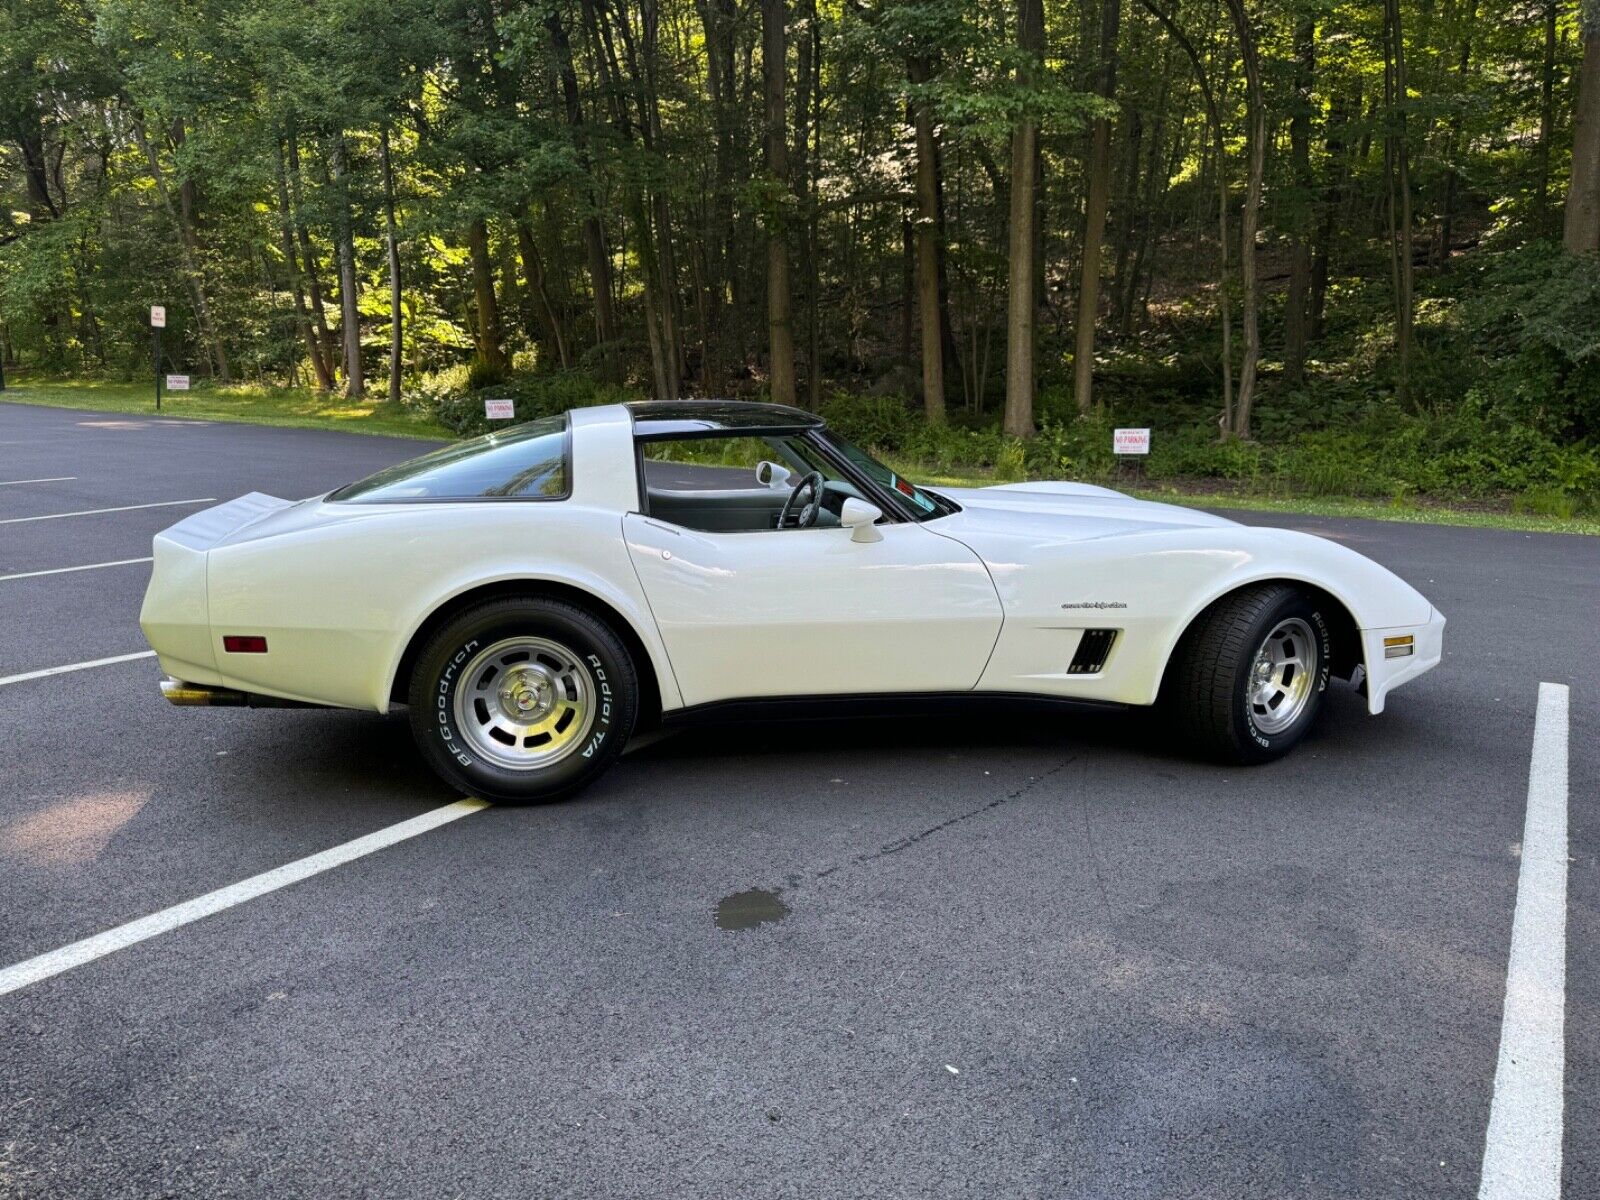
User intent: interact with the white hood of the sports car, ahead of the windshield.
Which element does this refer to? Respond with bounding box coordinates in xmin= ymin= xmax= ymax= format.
xmin=931 ymin=483 xmax=1238 ymax=542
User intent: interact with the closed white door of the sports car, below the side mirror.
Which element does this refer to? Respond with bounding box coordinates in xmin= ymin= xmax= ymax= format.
xmin=622 ymin=514 xmax=1000 ymax=704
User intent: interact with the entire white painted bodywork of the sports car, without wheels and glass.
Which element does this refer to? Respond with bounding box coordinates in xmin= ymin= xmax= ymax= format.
xmin=141 ymin=405 xmax=1445 ymax=723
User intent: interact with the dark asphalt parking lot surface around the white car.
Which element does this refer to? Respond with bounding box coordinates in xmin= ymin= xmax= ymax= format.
xmin=0 ymin=405 xmax=1600 ymax=1200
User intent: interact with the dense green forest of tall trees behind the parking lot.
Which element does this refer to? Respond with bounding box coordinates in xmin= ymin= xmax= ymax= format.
xmin=0 ymin=0 xmax=1600 ymax=510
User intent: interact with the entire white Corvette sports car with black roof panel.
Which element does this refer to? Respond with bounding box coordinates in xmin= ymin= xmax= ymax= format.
xmin=141 ymin=402 xmax=1445 ymax=800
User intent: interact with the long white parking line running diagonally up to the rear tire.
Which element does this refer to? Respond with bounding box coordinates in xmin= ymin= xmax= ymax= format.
xmin=0 ymin=800 xmax=488 ymax=995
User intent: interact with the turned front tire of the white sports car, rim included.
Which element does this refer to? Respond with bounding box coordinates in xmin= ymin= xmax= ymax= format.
xmin=1162 ymin=584 xmax=1333 ymax=765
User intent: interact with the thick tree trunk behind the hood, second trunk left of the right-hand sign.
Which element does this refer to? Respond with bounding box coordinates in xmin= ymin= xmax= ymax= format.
xmin=1004 ymin=0 xmax=1045 ymax=437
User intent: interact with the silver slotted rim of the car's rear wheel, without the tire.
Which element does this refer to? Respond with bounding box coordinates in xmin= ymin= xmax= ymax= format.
xmin=454 ymin=637 xmax=595 ymax=771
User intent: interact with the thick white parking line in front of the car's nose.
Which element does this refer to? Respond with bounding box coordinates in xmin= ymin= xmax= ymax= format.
xmin=1478 ymin=683 xmax=1568 ymax=1200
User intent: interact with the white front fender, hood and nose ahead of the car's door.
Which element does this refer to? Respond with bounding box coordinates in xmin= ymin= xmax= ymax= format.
xmin=926 ymin=483 xmax=1445 ymax=712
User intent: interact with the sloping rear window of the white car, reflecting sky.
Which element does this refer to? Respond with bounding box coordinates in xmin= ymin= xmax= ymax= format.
xmin=328 ymin=416 xmax=571 ymax=504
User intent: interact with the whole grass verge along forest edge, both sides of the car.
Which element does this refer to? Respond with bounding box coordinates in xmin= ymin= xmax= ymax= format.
xmin=0 ymin=379 xmax=1600 ymax=534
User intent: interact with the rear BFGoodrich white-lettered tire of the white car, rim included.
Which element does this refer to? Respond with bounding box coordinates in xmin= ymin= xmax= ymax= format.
xmin=406 ymin=595 xmax=638 ymax=803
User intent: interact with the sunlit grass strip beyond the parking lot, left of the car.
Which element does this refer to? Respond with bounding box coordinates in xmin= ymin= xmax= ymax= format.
xmin=0 ymin=379 xmax=451 ymax=440
